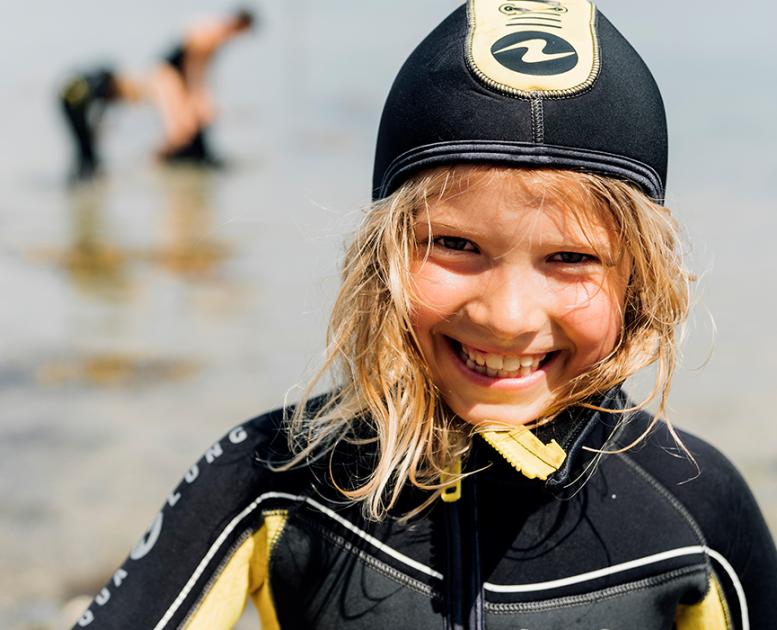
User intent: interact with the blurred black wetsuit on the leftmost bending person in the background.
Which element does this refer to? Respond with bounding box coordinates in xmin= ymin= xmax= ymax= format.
xmin=59 ymin=68 xmax=118 ymax=178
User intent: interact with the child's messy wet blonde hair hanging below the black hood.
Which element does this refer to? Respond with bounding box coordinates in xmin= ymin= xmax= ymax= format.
xmin=284 ymin=166 xmax=690 ymax=519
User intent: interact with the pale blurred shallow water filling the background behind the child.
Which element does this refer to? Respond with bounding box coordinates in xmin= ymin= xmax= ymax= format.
xmin=0 ymin=0 xmax=777 ymax=628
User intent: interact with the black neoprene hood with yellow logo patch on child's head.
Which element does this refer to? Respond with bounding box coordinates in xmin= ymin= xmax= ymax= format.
xmin=373 ymin=0 xmax=667 ymax=201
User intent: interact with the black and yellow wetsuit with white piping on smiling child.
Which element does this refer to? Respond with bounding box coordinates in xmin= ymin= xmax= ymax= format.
xmin=75 ymin=393 xmax=777 ymax=630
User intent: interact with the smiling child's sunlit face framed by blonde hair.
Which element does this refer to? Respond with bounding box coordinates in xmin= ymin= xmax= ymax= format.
xmin=411 ymin=167 xmax=630 ymax=425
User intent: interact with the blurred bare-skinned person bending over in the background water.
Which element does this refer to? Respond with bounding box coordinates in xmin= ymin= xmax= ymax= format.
xmin=152 ymin=10 xmax=254 ymax=167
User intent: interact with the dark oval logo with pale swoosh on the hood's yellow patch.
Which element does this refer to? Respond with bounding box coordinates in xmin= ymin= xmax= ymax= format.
xmin=491 ymin=31 xmax=578 ymax=76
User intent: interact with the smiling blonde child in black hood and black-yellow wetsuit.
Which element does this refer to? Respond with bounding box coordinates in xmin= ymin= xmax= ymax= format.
xmin=74 ymin=0 xmax=777 ymax=630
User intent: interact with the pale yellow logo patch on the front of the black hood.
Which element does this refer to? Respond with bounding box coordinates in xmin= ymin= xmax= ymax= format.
xmin=467 ymin=0 xmax=600 ymax=97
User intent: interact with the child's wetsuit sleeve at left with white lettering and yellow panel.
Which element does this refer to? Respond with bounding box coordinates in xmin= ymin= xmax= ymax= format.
xmin=69 ymin=419 xmax=285 ymax=630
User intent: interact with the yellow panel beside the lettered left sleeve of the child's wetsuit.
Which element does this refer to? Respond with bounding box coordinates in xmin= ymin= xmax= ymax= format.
xmin=185 ymin=510 xmax=286 ymax=630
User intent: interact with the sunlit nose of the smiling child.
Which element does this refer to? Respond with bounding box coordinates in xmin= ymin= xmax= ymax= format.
xmin=468 ymin=270 xmax=548 ymax=341
